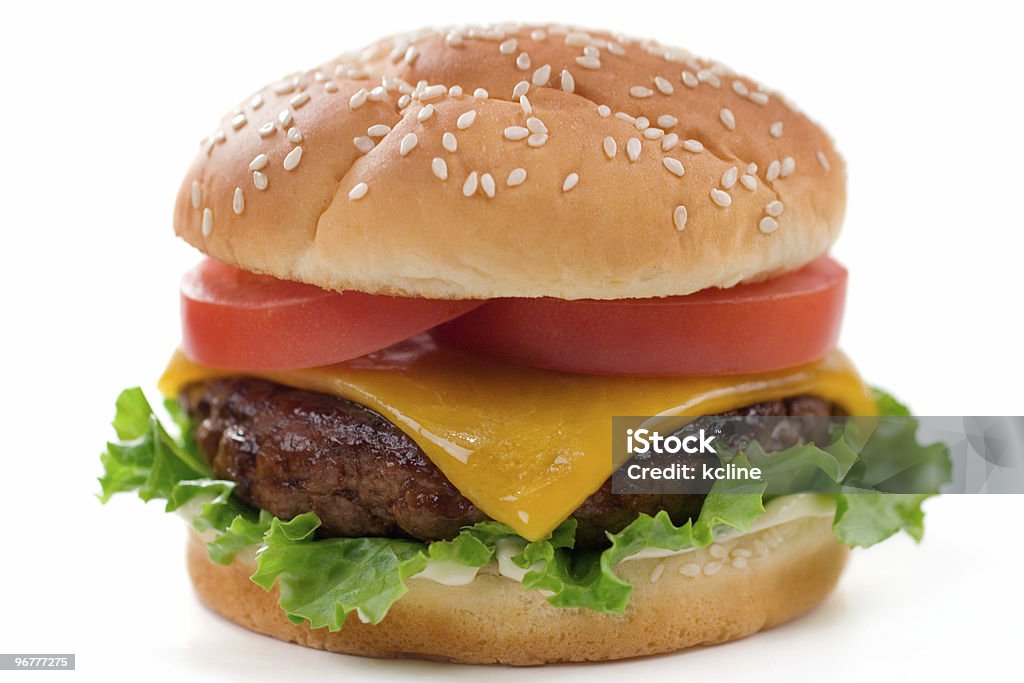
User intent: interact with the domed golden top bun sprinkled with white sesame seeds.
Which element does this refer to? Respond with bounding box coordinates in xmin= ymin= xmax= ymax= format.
xmin=174 ymin=26 xmax=846 ymax=299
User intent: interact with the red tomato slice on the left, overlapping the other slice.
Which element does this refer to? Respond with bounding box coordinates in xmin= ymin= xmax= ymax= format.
xmin=181 ymin=258 xmax=480 ymax=371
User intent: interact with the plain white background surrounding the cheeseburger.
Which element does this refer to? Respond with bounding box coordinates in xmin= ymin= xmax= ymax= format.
xmin=0 ymin=0 xmax=1024 ymax=681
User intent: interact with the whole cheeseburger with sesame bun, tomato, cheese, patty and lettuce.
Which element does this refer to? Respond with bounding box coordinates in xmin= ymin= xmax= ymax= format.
xmin=100 ymin=25 xmax=946 ymax=665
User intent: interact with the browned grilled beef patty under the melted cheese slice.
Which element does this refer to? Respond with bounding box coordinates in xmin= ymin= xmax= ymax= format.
xmin=180 ymin=377 xmax=834 ymax=547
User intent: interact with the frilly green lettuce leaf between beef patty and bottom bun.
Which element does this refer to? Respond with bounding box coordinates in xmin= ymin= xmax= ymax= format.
xmin=98 ymin=388 xmax=950 ymax=630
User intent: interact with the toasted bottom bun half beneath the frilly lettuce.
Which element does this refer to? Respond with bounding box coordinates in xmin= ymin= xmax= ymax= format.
xmin=188 ymin=517 xmax=849 ymax=665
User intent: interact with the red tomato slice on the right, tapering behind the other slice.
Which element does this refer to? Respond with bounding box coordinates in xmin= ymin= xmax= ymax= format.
xmin=431 ymin=257 xmax=847 ymax=376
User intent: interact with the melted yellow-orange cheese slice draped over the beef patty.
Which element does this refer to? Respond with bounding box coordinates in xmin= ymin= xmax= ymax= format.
xmin=160 ymin=337 xmax=877 ymax=541
